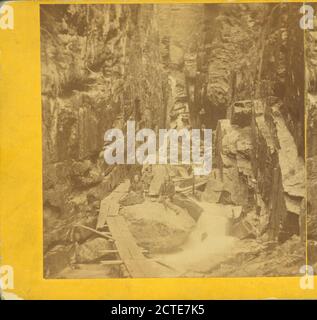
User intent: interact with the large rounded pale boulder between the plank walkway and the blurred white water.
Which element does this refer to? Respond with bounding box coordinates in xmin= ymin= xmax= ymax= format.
xmin=120 ymin=201 xmax=195 ymax=252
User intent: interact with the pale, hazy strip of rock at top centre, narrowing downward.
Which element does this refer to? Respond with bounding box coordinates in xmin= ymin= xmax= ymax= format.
xmin=157 ymin=4 xmax=205 ymax=127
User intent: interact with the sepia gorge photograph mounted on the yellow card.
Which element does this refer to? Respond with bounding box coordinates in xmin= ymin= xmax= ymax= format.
xmin=40 ymin=3 xmax=317 ymax=279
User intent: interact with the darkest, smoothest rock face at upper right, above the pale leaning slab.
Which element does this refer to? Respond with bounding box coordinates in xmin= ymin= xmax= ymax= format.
xmin=260 ymin=4 xmax=305 ymax=157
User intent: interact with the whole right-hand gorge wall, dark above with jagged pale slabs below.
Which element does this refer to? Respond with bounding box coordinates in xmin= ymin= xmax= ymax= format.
xmin=201 ymin=4 xmax=305 ymax=240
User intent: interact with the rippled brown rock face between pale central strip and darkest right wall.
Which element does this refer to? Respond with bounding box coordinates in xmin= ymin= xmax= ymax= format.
xmin=196 ymin=4 xmax=267 ymax=129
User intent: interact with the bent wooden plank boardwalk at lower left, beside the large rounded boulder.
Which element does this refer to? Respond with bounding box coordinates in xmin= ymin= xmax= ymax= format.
xmin=97 ymin=181 xmax=160 ymax=278
